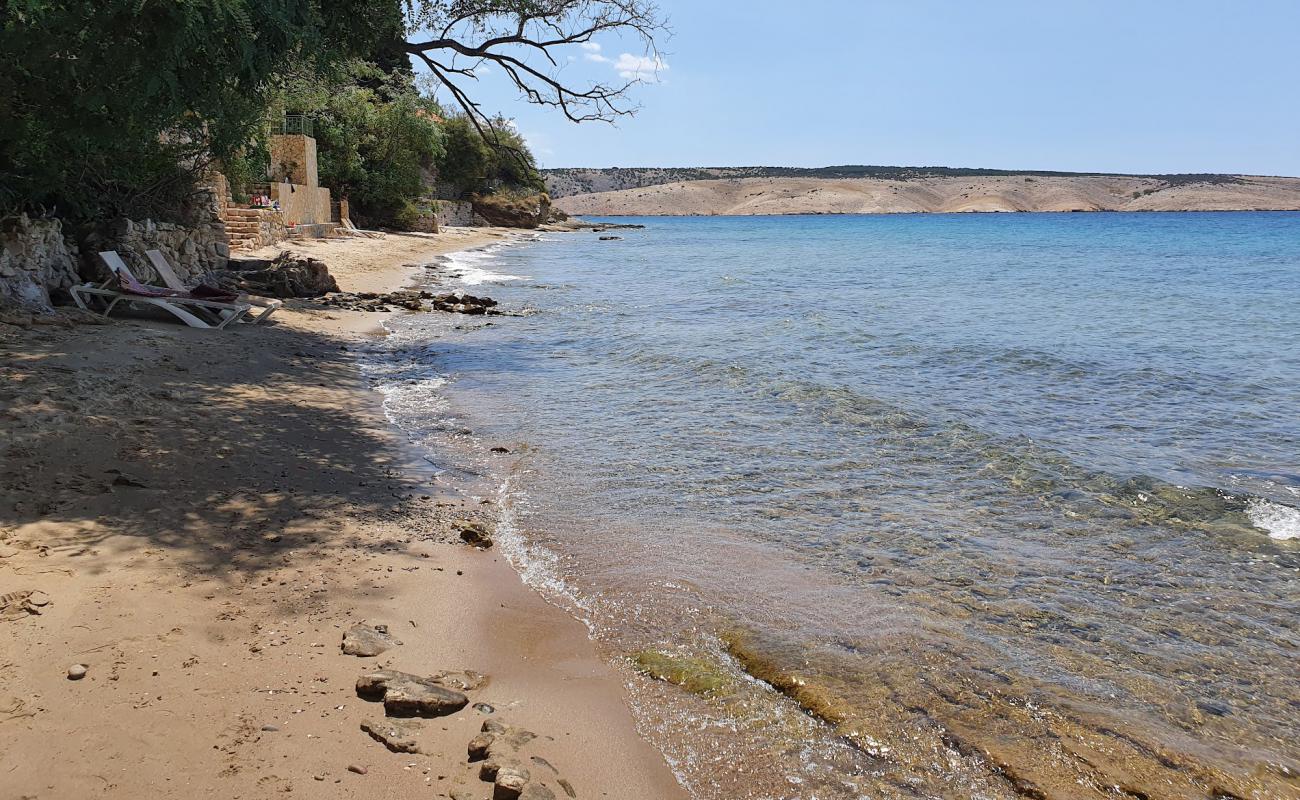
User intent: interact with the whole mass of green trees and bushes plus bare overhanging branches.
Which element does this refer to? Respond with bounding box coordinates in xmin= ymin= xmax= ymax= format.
xmin=0 ymin=0 xmax=647 ymax=224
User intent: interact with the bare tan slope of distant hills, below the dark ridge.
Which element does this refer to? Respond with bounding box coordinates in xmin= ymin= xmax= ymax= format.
xmin=555 ymin=176 xmax=1300 ymax=216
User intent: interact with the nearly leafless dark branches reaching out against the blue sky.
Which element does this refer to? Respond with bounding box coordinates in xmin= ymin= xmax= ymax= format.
xmin=406 ymin=0 xmax=666 ymax=150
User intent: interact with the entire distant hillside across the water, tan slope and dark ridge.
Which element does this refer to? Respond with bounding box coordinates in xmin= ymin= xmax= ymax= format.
xmin=545 ymin=167 xmax=1300 ymax=216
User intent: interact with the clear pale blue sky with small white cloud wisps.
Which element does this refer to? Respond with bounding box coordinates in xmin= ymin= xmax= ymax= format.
xmin=410 ymin=0 xmax=1300 ymax=176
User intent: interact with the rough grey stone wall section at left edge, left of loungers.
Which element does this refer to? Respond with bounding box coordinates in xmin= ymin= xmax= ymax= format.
xmin=0 ymin=216 xmax=79 ymax=312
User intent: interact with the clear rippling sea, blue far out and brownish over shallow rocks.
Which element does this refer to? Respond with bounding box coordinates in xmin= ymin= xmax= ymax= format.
xmin=373 ymin=213 xmax=1300 ymax=799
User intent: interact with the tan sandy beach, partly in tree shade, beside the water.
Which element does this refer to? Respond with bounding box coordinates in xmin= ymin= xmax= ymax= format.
xmin=0 ymin=230 xmax=683 ymax=800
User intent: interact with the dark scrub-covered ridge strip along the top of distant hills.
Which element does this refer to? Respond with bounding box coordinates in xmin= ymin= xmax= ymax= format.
xmin=542 ymin=165 xmax=1239 ymax=198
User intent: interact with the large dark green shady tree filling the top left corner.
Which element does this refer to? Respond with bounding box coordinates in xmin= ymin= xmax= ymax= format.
xmin=0 ymin=0 xmax=404 ymax=217
